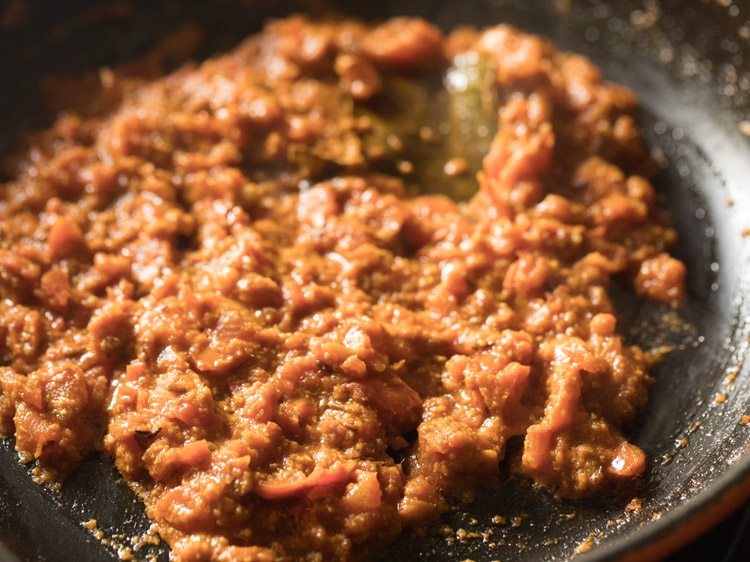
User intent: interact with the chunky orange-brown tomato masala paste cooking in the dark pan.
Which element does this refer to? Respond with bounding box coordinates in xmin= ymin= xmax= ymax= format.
xmin=0 ymin=17 xmax=685 ymax=562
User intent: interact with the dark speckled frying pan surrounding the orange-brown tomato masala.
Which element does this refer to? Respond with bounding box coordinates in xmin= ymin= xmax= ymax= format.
xmin=0 ymin=0 xmax=750 ymax=562
